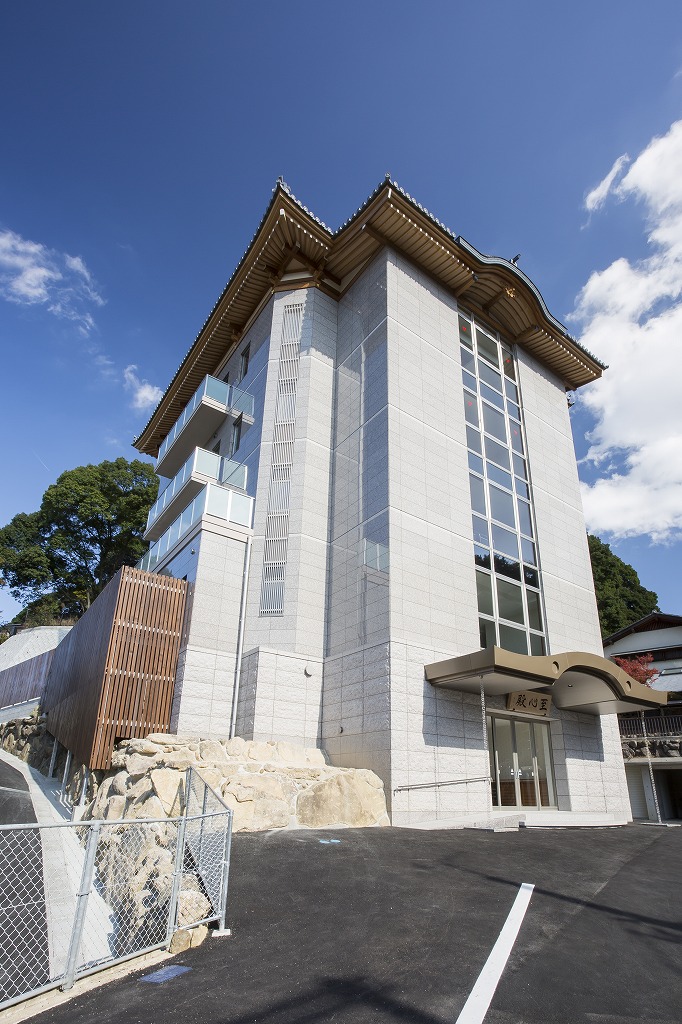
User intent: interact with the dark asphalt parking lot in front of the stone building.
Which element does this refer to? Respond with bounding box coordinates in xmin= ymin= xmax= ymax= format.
xmin=18 ymin=825 xmax=682 ymax=1024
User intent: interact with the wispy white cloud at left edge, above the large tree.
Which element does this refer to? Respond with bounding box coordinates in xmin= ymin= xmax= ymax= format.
xmin=0 ymin=228 xmax=104 ymax=335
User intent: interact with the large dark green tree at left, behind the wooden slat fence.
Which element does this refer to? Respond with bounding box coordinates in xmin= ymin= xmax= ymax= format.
xmin=0 ymin=459 xmax=159 ymax=613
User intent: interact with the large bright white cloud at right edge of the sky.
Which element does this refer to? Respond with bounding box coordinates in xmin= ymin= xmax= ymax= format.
xmin=571 ymin=121 xmax=682 ymax=543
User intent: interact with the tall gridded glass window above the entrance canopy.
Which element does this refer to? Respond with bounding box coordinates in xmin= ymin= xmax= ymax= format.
xmin=459 ymin=312 xmax=547 ymax=654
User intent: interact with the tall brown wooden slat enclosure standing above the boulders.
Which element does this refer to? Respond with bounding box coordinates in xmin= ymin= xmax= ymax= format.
xmin=43 ymin=566 xmax=187 ymax=768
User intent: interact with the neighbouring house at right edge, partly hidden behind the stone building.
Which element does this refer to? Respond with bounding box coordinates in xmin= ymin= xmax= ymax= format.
xmin=604 ymin=611 xmax=682 ymax=821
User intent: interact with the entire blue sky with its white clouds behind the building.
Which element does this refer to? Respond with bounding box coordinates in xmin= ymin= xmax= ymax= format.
xmin=0 ymin=0 xmax=682 ymax=618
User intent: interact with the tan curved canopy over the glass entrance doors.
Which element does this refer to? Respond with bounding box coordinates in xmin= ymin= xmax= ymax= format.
xmin=424 ymin=647 xmax=668 ymax=715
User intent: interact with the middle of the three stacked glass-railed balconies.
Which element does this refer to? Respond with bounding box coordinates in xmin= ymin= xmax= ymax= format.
xmin=144 ymin=449 xmax=247 ymax=541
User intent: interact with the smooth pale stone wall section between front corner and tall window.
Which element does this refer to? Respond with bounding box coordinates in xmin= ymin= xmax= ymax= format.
xmin=387 ymin=255 xmax=478 ymax=656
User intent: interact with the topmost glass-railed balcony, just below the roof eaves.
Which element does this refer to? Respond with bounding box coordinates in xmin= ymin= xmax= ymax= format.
xmin=156 ymin=377 xmax=254 ymax=476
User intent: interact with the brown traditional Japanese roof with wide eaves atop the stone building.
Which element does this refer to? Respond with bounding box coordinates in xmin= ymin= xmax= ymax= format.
xmin=135 ymin=178 xmax=605 ymax=456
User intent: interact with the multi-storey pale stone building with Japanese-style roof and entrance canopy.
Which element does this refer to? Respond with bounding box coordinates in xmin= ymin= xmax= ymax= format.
xmin=135 ymin=180 xmax=665 ymax=824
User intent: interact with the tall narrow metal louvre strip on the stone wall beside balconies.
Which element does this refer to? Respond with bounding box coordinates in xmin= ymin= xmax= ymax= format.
xmin=259 ymin=302 xmax=303 ymax=615
